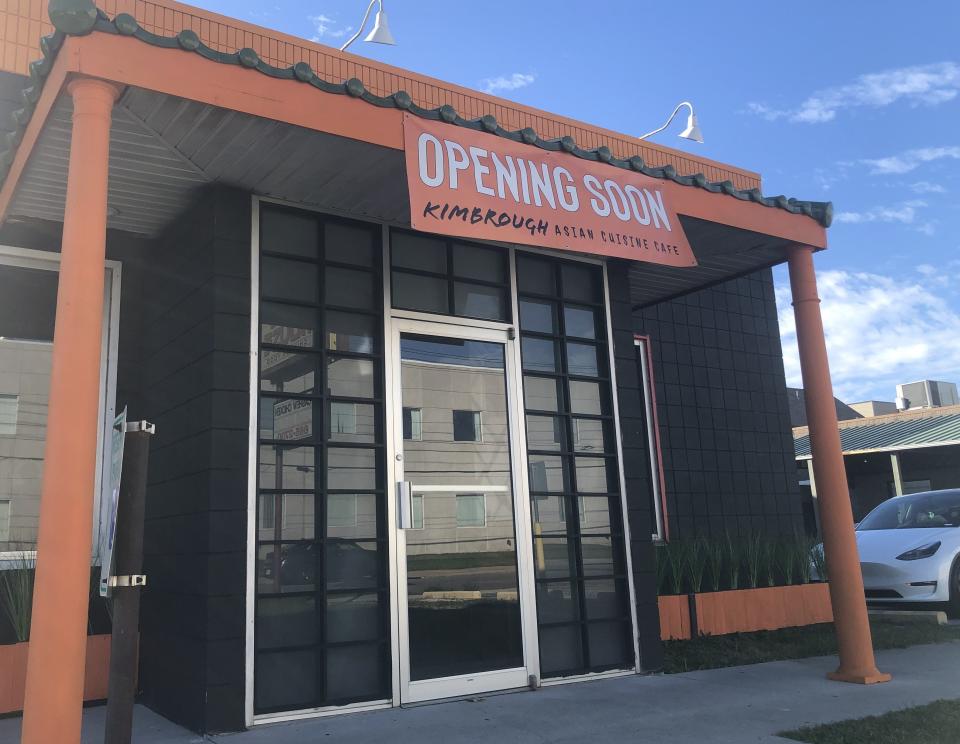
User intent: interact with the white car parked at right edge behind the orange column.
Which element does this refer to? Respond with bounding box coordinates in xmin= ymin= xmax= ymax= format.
xmin=857 ymin=488 xmax=960 ymax=617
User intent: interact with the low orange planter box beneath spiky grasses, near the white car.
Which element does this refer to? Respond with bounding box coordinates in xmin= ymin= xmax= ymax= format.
xmin=658 ymin=584 xmax=833 ymax=641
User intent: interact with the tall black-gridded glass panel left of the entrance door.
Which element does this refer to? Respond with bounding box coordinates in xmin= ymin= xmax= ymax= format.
xmin=254 ymin=206 xmax=390 ymax=714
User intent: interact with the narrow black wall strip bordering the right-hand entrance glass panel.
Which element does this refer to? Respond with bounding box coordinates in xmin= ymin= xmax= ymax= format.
xmin=607 ymin=261 xmax=663 ymax=671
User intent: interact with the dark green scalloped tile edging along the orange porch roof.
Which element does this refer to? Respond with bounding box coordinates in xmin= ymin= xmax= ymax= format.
xmin=0 ymin=0 xmax=833 ymax=227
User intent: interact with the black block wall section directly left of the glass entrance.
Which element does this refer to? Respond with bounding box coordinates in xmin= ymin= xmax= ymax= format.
xmin=131 ymin=188 xmax=251 ymax=731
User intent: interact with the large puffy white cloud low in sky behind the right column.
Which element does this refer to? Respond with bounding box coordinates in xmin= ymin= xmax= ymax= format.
xmin=777 ymin=265 xmax=960 ymax=402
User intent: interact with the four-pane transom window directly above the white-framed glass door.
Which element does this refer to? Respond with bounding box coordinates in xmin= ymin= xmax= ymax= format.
xmin=390 ymin=230 xmax=510 ymax=322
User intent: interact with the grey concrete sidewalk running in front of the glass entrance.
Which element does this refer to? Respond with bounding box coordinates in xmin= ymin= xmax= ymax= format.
xmin=0 ymin=643 xmax=960 ymax=744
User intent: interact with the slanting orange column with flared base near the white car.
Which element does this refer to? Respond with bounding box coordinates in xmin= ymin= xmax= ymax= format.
xmin=789 ymin=246 xmax=890 ymax=684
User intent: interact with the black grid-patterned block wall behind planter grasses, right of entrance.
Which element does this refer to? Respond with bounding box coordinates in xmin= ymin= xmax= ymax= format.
xmin=633 ymin=269 xmax=803 ymax=538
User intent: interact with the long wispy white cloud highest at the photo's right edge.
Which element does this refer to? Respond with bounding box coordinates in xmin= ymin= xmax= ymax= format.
xmin=747 ymin=62 xmax=960 ymax=124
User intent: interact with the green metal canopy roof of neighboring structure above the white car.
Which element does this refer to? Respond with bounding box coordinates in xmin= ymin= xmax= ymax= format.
xmin=793 ymin=406 xmax=960 ymax=460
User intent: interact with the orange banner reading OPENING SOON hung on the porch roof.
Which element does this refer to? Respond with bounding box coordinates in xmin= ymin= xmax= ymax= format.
xmin=403 ymin=114 xmax=697 ymax=266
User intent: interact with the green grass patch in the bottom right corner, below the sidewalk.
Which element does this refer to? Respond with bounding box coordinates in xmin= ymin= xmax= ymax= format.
xmin=778 ymin=700 xmax=960 ymax=744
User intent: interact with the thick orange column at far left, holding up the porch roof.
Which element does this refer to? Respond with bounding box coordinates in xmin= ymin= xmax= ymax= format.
xmin=21 ymin=78 xmax=119 ymax=744
